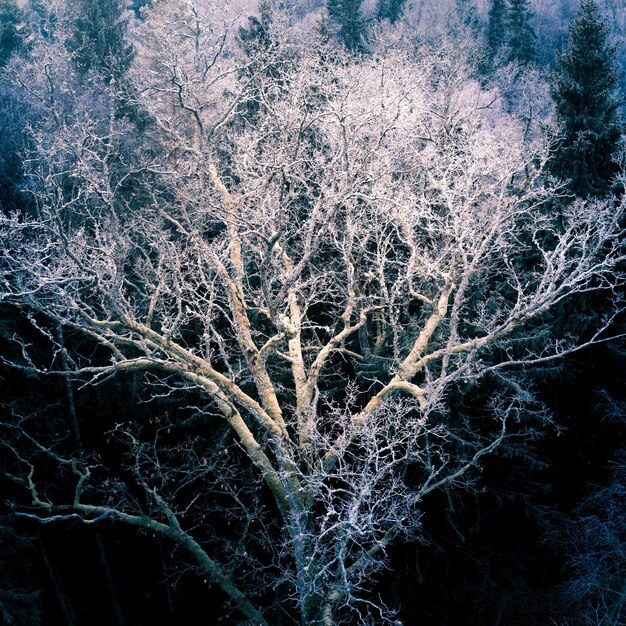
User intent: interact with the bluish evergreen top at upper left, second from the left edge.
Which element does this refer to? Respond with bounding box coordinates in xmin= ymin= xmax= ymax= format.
xmin=71 ymin=0 xmax=133 ymax=80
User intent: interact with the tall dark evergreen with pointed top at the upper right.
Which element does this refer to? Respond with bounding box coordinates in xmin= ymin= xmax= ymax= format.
xmin=551 ymin=0 xmax=621 ymax=196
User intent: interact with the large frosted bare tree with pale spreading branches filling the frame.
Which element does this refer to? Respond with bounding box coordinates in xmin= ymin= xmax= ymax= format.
xmin=0 ymin=1 xmax=623 ymax=626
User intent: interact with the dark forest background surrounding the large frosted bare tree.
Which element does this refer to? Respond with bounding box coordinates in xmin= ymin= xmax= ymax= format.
xmin=0 ymin=0 xmax=626 ymax=626
